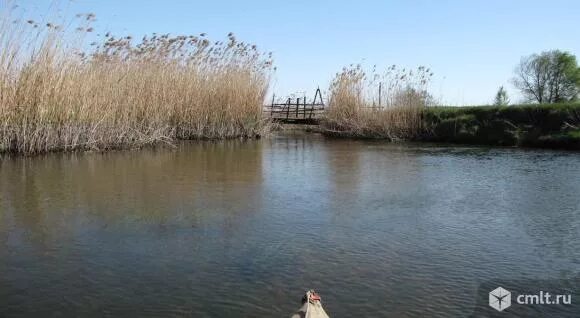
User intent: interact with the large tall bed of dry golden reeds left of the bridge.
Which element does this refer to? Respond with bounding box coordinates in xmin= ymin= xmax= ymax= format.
xmin=0 ymin=10 xmax=272 ymax=154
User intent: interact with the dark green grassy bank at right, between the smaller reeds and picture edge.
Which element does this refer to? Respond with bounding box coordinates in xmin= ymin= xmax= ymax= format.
xmin=417 ymin=104 xmax=580 ymax=149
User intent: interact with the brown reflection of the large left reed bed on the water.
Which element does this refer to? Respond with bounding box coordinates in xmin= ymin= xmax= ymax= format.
xmin=0 ymin=141 xmax=262 ymax=244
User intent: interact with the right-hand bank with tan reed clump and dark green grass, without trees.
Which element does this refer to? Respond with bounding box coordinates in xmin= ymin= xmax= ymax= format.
xmin=320 ymin=66 xmax=580 ymax=149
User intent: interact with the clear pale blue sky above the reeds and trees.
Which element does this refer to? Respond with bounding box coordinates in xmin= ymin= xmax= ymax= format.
xmin=12 ymin=0 xmax=580 ymax=106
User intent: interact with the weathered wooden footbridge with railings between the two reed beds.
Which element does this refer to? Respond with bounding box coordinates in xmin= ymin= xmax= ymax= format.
xmin=264 ymin=88 xmax=324 ymax=125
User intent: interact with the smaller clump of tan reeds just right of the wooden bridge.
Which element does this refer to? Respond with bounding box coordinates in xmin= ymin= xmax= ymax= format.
xmin=321 ymin=65 xmax=433 ymax=140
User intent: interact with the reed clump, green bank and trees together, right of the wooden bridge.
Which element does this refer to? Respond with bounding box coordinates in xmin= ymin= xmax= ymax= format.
xmin=321 ymin=50 xmax=580 ymax=149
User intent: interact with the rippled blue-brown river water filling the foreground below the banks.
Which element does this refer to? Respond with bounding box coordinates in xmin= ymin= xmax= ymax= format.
xmin=0 ymin=135 xmax=580 ymax=317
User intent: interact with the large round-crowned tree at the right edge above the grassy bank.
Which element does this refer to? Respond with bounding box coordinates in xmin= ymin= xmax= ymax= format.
xmin=513 ymin=50 xmax=580 ymax=103
